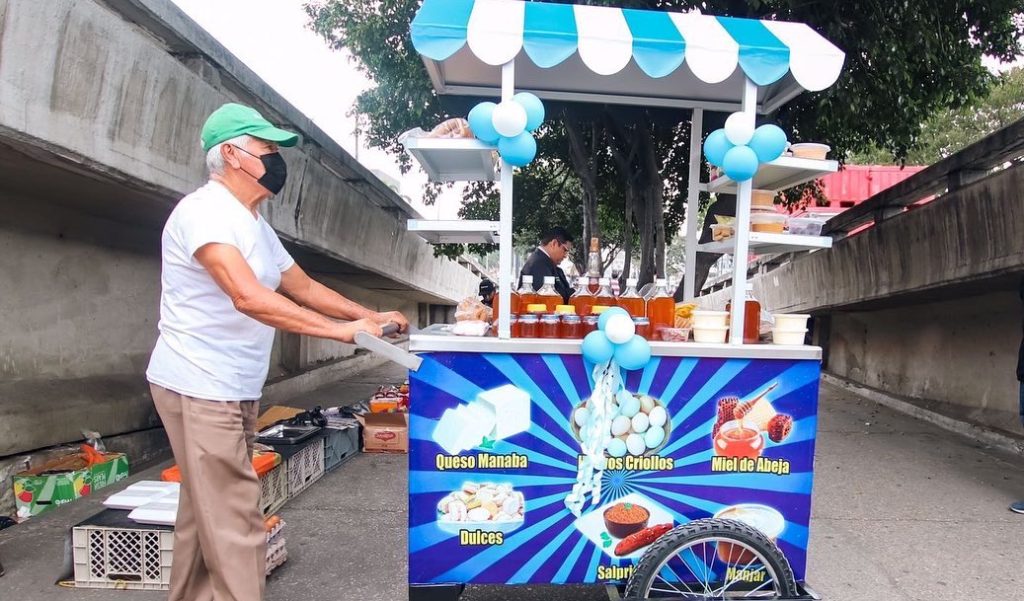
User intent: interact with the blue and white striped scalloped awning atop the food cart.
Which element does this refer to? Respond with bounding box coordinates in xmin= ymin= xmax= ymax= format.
xmin=412 ymin=0 xmax=845 ymax=112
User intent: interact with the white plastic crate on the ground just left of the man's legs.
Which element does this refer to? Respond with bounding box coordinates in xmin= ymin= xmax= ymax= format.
xmin=72 ymin=526 xmax=174 ymax=591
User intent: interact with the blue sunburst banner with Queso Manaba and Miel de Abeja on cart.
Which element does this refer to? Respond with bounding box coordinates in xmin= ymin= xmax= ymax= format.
xmin=409 ymin=353 xmax=820 ymax=585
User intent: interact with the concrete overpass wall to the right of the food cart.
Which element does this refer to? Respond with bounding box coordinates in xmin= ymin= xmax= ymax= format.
xmin=701 ymin=161 xmax=1024 ymax=440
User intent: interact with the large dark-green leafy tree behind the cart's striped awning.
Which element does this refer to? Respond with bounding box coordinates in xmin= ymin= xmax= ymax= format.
xmin=306 ymin=0 xmax=1024 ymax=280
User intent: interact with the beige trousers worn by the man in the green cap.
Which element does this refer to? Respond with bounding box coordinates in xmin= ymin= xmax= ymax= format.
xmin=150 ymin=385 xmax=266 ymax=601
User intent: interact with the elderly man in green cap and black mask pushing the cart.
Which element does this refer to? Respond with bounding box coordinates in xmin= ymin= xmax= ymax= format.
xmin=146 ymin=104 xmax=409 ymax=601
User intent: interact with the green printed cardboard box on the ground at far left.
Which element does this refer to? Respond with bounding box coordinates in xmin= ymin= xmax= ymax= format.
xmin=14 ymin=453 xmax=128 ymax=518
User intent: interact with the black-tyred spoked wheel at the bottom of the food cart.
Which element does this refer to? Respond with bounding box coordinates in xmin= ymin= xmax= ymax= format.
xmin=626 ymin=519 xmax=800 ymax=600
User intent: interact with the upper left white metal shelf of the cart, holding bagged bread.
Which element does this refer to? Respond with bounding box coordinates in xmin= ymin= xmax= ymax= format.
xmin=402 ymin=136 xmax=499 ymax=181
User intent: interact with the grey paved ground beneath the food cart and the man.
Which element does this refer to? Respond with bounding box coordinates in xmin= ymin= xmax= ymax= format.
xmin=0 ymin=370 xmax=1024 ymax=601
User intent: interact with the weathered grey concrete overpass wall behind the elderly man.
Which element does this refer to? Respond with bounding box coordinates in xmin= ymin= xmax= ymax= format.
xmin=0 ymin=0 xmax=478 ymax=515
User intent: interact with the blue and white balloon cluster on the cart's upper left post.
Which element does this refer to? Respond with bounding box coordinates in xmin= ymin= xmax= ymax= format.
xmin=469 ymin=92 xmax=544 ymax=167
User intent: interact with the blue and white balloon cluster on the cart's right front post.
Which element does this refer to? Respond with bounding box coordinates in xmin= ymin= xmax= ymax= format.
xmin=705 ymin=113 xmax=790 ymax=182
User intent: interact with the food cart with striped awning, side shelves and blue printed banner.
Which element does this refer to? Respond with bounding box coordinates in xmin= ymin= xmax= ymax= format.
xmin=395 ymin=0 xmax=845 ymax=599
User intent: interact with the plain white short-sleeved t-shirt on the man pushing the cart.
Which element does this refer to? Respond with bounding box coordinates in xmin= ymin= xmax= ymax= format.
xmin=146 ymin=181 xmax=295 ymax=400
